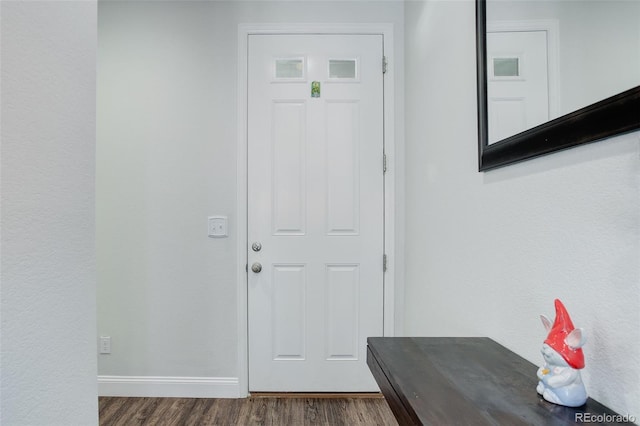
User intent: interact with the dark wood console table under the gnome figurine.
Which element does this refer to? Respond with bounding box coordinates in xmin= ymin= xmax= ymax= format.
xmin=367 ymin=337 xmax=628 ymax=425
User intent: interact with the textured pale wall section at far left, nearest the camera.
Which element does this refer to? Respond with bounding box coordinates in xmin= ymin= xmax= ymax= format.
xmin=0 ymin=1 xmax=98 ymax=426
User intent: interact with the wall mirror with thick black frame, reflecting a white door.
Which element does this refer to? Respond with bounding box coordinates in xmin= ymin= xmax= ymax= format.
xmin=476 ymin=0 xmax=640 ymax=171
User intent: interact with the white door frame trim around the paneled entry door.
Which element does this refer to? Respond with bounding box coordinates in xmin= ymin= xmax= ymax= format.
xmin=235 ymin=24 xmax=396 ymax=397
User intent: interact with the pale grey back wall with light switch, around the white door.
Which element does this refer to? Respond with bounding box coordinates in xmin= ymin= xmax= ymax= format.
xmin=97 ymin=1 xmax=404 ymax=391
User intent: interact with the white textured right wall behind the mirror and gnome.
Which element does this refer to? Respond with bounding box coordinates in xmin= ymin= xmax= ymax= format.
xmin=405 ymin=1 xmax=640 ymax=417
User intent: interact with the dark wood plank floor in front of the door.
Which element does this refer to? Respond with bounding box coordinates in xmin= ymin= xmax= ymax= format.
xmin=100 ymin=396 xmax=398 ymax=426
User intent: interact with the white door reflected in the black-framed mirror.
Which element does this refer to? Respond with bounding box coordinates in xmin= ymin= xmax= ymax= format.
xmin=487 ymin=31 xmax=549 ymax=143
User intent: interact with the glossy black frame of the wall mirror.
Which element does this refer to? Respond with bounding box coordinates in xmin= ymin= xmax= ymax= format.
xmin=476 ymin=0 xmax=640 ymax=171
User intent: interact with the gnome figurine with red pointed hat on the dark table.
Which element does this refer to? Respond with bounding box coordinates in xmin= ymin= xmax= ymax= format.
xmin=536 ymin=299 xmax=587 ymax=407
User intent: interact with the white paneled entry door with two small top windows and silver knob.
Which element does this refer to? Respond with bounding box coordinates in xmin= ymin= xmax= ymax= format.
xmin=247 ymin=35 xmax=384 ymax=392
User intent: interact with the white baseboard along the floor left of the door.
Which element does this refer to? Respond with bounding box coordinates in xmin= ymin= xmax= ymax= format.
xmin=98 ymin=376 xmax=244 ymax=398
